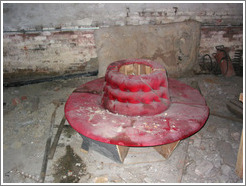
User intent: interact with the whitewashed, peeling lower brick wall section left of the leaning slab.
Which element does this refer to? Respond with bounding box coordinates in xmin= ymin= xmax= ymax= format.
xmin=3 ymin=30 xmax=98 ymax=78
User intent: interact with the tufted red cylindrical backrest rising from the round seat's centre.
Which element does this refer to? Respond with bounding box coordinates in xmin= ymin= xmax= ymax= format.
xmin=102 ymin=59 xmax=170 ymax=116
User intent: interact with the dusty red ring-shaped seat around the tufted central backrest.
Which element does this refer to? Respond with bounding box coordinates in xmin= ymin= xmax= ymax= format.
xmin=65 ymin=77 xmax=209 ymax=147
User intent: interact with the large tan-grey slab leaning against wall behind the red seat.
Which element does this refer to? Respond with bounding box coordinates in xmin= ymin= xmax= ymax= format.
xmin=95 ymin=21 xmax=200 ymax=77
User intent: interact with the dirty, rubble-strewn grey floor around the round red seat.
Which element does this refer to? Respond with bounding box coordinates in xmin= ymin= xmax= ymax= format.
xmin=1 ymin=75 xmax=244 ymax=183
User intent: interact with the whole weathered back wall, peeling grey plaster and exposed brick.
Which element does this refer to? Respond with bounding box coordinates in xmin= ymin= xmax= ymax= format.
xmin=3 ymin=3 xmax=243 ymax=78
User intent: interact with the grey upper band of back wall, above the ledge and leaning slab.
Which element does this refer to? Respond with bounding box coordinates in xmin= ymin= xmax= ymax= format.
xmin=3 ymin=3 xmax=243 ymax=31
